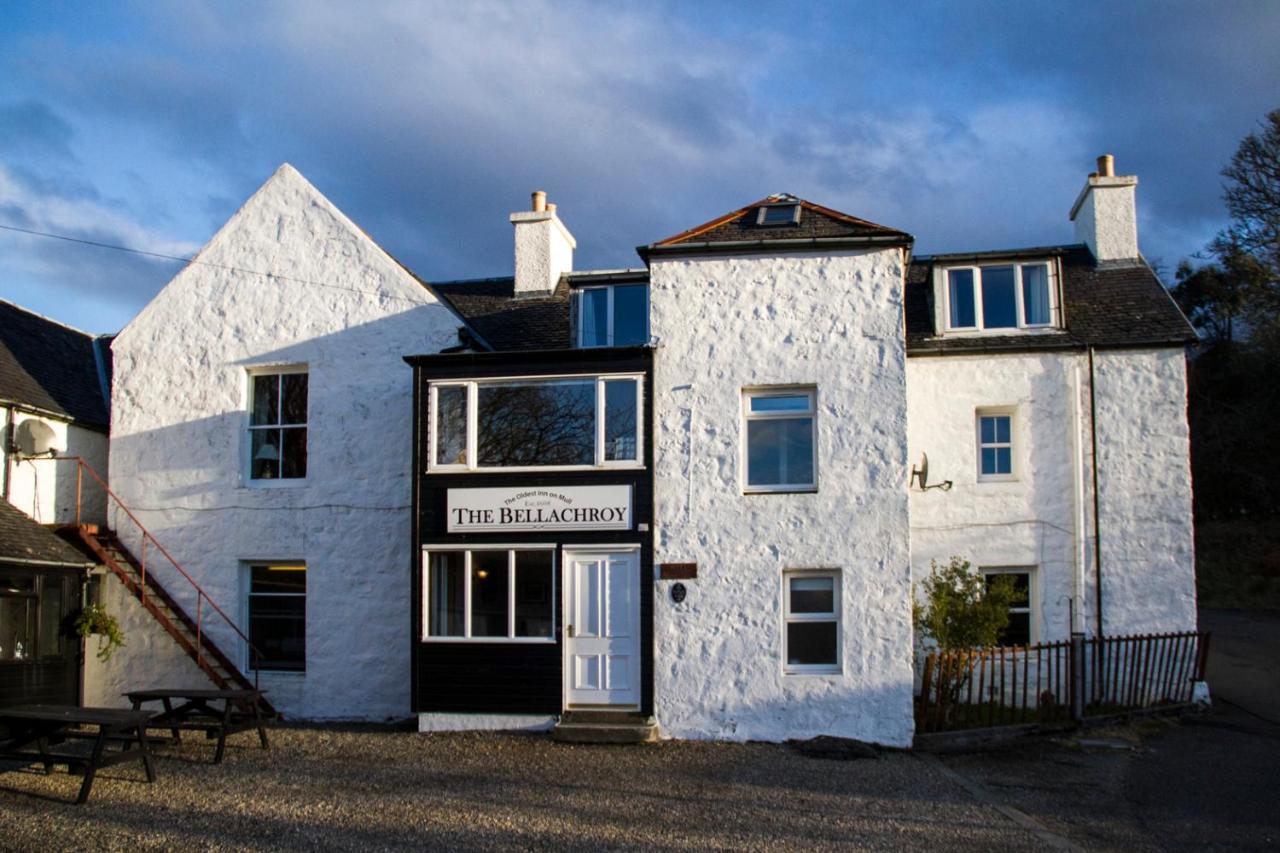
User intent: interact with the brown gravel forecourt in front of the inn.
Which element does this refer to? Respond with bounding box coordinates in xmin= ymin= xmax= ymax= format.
xmin=0 ymin=727 xmax=1044 ymax=850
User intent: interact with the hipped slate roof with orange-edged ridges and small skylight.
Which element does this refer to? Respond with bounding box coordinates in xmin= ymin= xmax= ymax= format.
xmin=641 ymin=193 xmax=914 ymax=256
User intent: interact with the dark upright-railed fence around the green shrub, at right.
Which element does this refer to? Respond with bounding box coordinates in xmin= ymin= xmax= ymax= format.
xmin=915 ymin=633 xmax=1208 ymax=733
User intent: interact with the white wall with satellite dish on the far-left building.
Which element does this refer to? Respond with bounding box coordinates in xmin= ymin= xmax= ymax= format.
xmin=0 ymin=409 xmax=108 ymax=524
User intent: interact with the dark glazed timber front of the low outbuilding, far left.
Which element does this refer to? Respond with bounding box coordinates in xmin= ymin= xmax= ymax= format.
xmin=0 ymin=562 xmax=81 ymax=707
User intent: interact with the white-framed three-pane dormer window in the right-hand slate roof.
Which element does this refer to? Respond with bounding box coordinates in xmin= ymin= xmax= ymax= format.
xmin=942 ymin=261 xmax=1061 ymax=332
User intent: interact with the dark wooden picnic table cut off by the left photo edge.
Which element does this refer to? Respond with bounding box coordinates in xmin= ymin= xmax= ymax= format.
xmin=0 ymin=704 xmax=156 ymax=806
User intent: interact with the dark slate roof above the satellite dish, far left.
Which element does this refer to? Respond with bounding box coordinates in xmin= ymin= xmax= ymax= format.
xmin=0 ymin=300 xmax=111 ymax=429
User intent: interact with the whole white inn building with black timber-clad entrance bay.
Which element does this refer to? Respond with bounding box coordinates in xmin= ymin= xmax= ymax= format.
xmin=92 ymin=154 xmax=1196 ymax=745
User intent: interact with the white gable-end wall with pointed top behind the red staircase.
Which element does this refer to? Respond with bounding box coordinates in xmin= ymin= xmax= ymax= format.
xmin=111 ymin=167 xmax=460 ymax=719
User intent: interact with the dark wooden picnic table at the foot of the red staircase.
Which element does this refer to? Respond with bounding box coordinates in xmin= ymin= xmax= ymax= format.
xmin=124 ymin=688 xmax=270 ymax=765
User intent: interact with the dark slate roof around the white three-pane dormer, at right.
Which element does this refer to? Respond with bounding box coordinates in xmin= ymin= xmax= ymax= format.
xmin=906 ymin=245 xmax=1197 ymax=355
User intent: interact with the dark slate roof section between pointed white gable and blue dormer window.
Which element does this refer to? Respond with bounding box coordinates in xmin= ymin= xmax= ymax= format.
xmin=430 ymin=277 xmax=570 ymax=350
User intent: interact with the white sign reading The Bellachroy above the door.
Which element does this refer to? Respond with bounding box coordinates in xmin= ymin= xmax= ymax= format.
xmin=448 ymin=485 xmax=631 ymax=533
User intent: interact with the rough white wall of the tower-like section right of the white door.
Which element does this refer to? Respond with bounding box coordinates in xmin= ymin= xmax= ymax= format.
xmin=650 ymin=250 xmax=913 ymax=745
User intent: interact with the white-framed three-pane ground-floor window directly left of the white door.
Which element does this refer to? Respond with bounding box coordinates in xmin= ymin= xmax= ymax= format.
xmin=422 ymin=544 xmax=556 ymax=643
